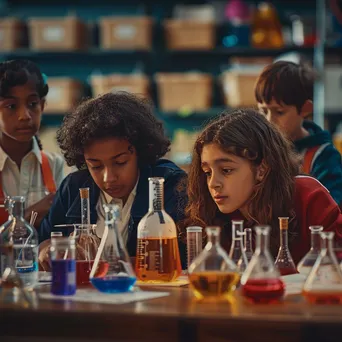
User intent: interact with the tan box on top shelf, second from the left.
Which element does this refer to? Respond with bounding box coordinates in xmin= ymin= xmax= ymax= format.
xmin=29 ymin=16 xmax=88 ymax=51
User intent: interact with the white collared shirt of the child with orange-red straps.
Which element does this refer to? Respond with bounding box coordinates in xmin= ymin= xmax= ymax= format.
xmin=0 ymin=139 xmax=64 ymax=207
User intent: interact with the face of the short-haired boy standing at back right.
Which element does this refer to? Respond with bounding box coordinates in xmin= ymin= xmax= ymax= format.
xmin=258 ymin=99 xmax=304 ymax=141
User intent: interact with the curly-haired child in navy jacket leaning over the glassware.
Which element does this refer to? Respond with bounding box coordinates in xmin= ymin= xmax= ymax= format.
xmin=39 ymin=92 xmax=187 ymax=266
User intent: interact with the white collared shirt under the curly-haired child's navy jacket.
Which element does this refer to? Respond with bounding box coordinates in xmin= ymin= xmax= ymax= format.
xmin=96 ymin=177 xmax=139 ymax=245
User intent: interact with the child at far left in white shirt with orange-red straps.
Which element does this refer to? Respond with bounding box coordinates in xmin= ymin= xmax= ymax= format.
xmin=0 ymin=60 xmax=64 ymax=226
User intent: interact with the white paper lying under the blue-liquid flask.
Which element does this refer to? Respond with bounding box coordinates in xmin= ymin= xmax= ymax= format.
xmin=39 ymin=289 xmax=170 ymax=304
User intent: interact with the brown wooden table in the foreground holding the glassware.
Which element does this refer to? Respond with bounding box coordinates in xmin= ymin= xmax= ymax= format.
xmin=0 ymin=288 xmax=342 ymax=342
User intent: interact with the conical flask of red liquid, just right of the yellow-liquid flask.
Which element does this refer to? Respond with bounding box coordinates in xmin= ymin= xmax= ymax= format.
xmin=241 ymin=226 xmax=285 ymax=303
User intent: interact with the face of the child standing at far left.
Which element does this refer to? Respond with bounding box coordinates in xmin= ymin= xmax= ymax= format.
xmin=0 ymin=80 xmax=44 ymax=142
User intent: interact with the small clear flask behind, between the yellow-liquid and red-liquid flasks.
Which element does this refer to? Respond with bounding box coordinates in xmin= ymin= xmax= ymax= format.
xmin=229 ymin=220 xmax=248 ymax=273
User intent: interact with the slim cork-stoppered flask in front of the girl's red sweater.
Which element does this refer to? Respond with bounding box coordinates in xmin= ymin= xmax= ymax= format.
xmin=275 ymin=217 xmax=298 ymax=276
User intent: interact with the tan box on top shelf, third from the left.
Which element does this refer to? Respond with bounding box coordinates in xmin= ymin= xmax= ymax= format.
xmin=100 ymin=17 xmax=152 ymax=50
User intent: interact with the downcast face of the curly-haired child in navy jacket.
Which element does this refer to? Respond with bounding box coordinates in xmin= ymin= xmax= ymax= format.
xmin=84 ymin=138 xmax=139 ymax=203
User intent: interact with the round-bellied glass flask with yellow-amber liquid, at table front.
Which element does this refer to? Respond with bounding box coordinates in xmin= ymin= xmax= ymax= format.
xmin=188 ymin=227 xmax=240 ymax=300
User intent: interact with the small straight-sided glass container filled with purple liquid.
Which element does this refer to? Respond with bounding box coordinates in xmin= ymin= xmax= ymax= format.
xmin=50 ymin=237 xmax=76 ymax=296
